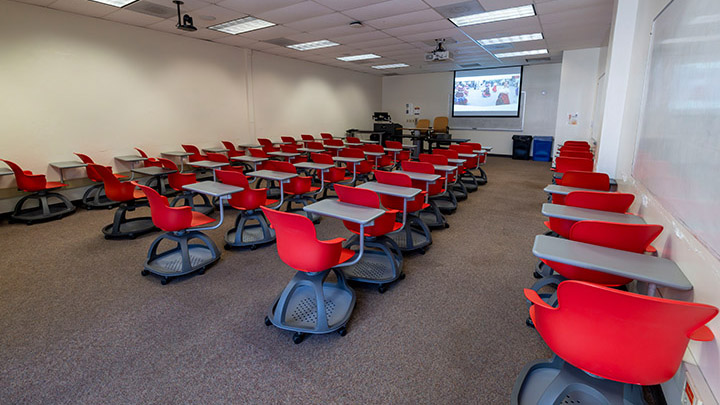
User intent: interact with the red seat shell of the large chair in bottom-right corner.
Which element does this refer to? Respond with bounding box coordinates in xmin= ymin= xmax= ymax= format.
xmin=525 ymin=281 xmax=718 ymax=385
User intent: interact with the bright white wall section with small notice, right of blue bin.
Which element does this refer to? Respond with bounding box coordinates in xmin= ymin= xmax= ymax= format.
xmin=555 ymin=48 xmax=602 ymax=155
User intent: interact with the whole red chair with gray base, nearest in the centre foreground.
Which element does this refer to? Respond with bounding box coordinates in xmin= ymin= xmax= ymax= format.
xmin=261 ymin=207 xmax=355 ymax=344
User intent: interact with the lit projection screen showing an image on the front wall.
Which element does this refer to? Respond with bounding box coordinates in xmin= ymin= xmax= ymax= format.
xmin=453 ymin=66 xmax=522 ymax=117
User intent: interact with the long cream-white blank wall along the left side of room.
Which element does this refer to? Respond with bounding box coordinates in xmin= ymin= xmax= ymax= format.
xmin=0 ymin=0 xmax=381 ymax=205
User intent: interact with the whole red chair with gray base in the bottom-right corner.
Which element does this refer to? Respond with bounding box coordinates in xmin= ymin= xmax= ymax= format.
xmin=511 ymin=281 xmax=718 ymax=405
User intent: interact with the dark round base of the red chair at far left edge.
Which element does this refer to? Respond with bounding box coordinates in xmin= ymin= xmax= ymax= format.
xmin=10 ymin=191 xmax=75 ymax=225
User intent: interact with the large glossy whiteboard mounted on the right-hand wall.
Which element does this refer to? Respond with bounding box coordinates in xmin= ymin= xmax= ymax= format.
xmin=633 ymin=0 xmax=720 ymax=258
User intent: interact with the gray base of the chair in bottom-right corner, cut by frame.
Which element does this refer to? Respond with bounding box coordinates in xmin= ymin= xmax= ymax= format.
xmin=511 ymin=356 xmax=645 ymax=405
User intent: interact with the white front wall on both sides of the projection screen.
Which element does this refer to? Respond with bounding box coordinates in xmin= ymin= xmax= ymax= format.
xmin=382 ymin=63 xmax=560 ymax=155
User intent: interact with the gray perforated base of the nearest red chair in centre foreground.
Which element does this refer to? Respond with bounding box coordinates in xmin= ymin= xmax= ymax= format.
xmin=265 ymin=269 xmax=355 ymax=344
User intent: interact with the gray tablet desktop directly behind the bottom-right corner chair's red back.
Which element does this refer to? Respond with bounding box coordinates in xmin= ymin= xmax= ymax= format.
xmin=533 ymin=235 xmax=693 ymax=296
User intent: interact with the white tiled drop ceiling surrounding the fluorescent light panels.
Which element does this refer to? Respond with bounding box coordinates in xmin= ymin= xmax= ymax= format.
xmin=12 ymin=0 xmax=613 ymax=75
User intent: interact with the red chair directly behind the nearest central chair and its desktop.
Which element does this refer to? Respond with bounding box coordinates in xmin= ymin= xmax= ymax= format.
xmin=335 ymin=184 xmax=405 ymax=294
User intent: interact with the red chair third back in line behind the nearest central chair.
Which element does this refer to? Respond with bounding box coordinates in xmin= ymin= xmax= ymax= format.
xmin=374 ymin=170 xmax=432 ymax=254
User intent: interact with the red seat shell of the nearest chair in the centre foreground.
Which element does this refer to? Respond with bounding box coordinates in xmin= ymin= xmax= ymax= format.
xmin=261 ymin=207 xmax=342 ymax=272
